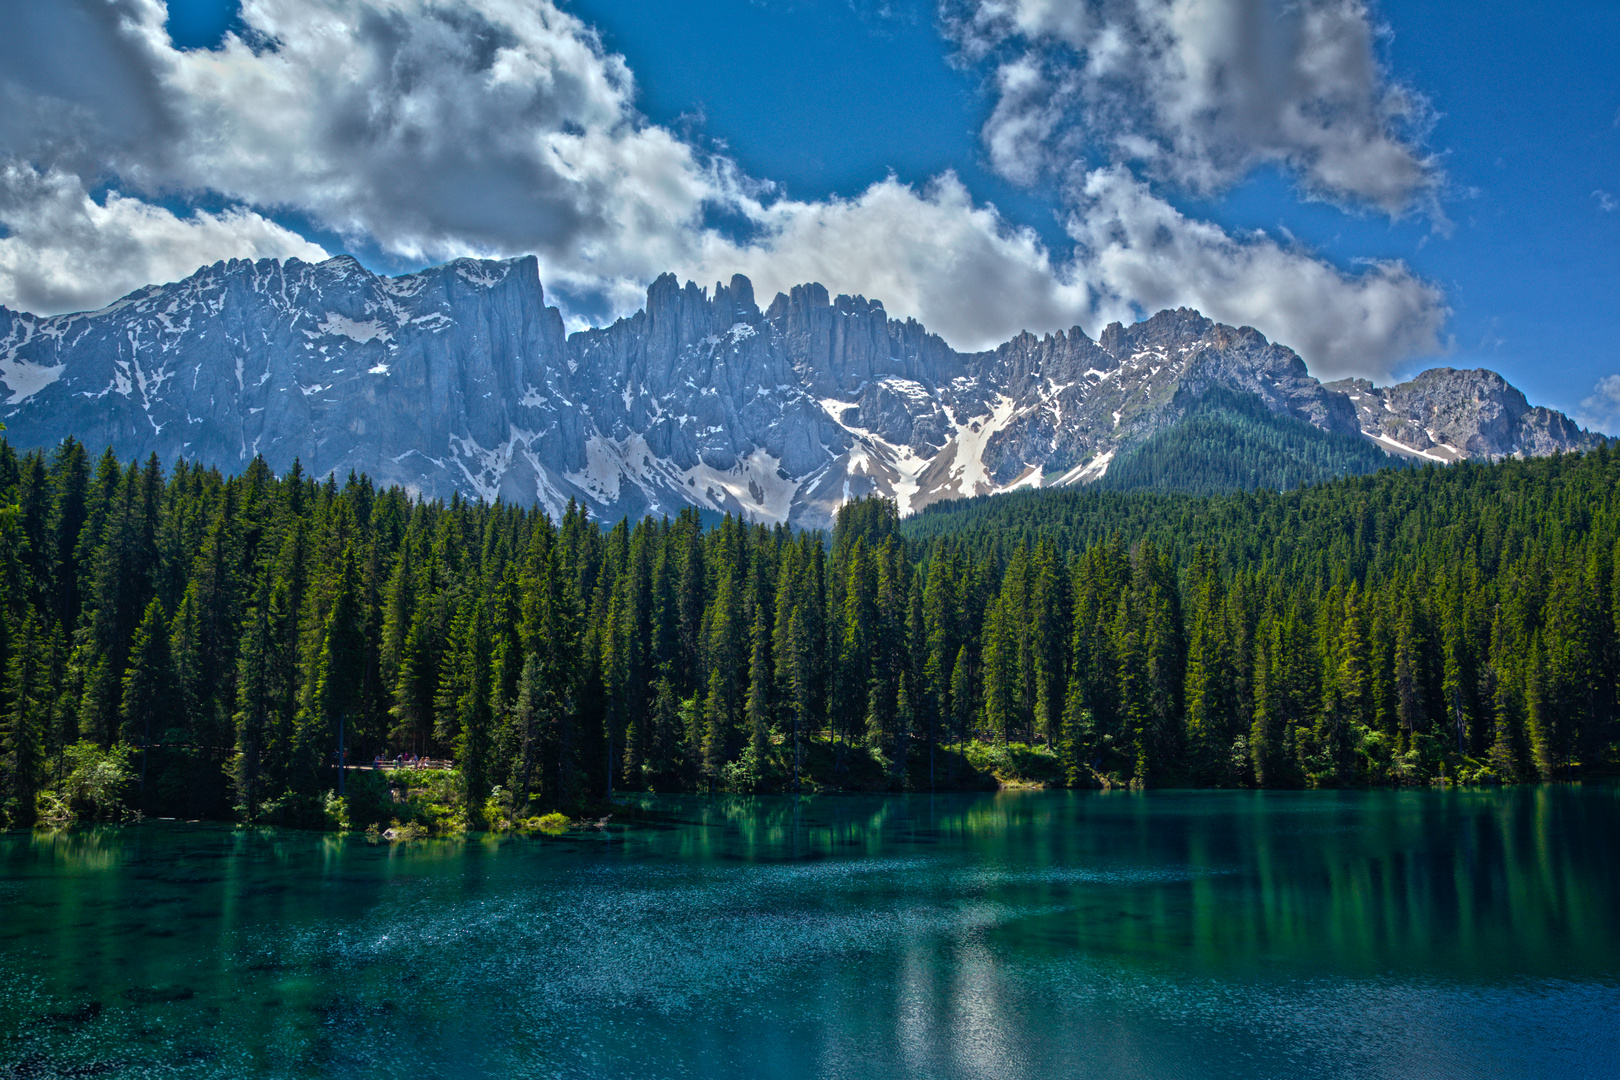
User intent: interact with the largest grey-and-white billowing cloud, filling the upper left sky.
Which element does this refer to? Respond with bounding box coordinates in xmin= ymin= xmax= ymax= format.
xmin=0 ymin=0 xmax=742 ymax=312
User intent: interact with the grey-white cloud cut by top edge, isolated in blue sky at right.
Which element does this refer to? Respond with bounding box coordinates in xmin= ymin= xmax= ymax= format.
xmin=941 ymin=0 xmax=1437 ymax=214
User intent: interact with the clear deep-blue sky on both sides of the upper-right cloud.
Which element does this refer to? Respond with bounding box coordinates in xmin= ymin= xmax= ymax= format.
xmin=570 ymin=0 xmax=1620 ymax=427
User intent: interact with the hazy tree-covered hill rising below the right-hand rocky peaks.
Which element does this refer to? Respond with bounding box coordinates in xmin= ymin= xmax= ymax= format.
xmin=1097 ymin=389 xmax=1409 ymax=495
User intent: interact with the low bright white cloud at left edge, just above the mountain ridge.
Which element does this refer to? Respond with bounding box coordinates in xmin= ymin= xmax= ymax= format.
xmin=0 ymin=162 xmax=327 ymax=314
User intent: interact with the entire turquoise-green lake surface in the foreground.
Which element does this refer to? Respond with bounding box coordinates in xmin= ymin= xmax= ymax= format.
xmin=0 ymin=785 xmax=1620 ymax=1080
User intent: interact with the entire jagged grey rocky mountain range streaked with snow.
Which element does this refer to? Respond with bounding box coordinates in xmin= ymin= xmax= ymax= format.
xmin=0 ymin=256 xmax=1601 ymax=526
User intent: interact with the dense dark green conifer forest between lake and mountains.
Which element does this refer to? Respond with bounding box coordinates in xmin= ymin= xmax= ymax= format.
xmin=0 ymin=440 xmax=1620 ymax=827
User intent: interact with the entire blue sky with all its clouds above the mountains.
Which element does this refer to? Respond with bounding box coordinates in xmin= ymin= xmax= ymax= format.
xmin=0 ymin=0 xmax=1620 ymax=431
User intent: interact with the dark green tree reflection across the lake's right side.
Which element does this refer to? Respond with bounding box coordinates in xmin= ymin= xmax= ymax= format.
xmin=635 ymin=787 xmax=1620 ymax=975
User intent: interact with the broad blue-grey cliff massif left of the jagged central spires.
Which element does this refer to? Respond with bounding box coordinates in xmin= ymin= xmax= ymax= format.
xmin=0 ymin=257 xmax=583 ymax=499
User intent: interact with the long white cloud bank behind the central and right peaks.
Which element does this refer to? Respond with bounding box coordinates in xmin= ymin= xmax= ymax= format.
xmin=667 ymin=167 xmax=1450 ymax=381
